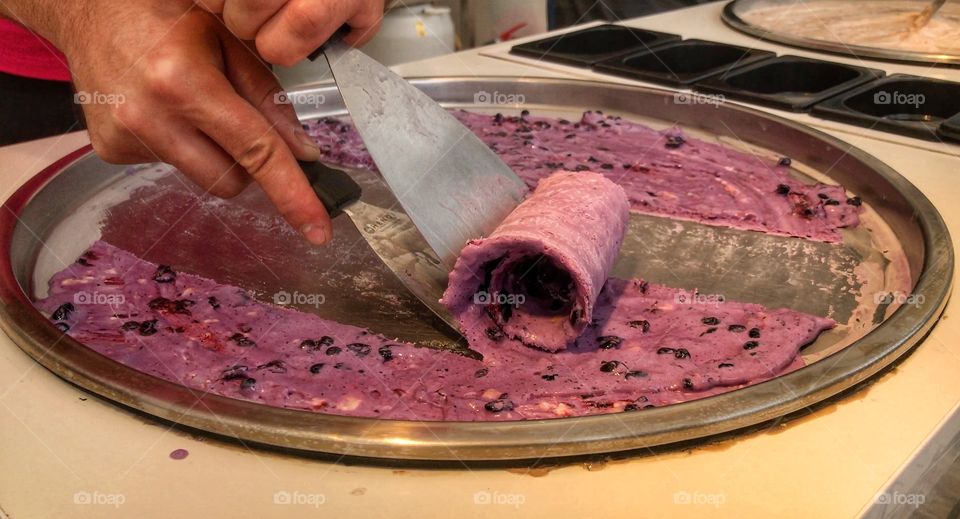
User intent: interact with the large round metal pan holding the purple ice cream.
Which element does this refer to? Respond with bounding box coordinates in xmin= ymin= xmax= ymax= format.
xmin=0 ymin=77 xmax=953 ymax=461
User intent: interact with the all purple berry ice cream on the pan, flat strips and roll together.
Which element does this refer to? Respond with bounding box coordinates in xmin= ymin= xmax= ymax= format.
xmin=31 ymin=107 xmax=860 ymax=421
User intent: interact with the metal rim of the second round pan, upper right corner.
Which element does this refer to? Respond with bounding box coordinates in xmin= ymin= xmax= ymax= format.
xmin=721 ymin=0 xmax=960 ymax=67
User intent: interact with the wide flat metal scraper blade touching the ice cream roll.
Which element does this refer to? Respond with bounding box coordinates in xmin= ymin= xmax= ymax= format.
xmin=310 ymin=30 xmax=527 ymax=268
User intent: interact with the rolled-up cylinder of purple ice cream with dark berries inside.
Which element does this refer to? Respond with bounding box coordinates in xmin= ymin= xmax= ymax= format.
xmin=442 ymin=171 xmax=630 ymax=354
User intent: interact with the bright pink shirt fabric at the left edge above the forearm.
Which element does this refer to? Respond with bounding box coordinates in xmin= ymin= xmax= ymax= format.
xmin=0 ymin=18 xmax=70 ymax=81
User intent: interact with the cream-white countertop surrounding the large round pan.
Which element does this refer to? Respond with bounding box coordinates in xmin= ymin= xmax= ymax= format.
xmin=0 ymin=4 xmax=960 ymax=519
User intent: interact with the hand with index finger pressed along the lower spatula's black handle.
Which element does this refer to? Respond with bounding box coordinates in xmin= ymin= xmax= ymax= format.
xmin=60 ymin=0 xmax=344 ymax=244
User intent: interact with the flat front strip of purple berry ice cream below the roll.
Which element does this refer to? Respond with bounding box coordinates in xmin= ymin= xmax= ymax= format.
xmin=37 ymin=241 xmax=834 ymax=420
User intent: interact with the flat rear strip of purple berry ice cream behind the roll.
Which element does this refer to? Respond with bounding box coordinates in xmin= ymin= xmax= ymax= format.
xmin=307 ymin=110 xmax=859 ymax=243
